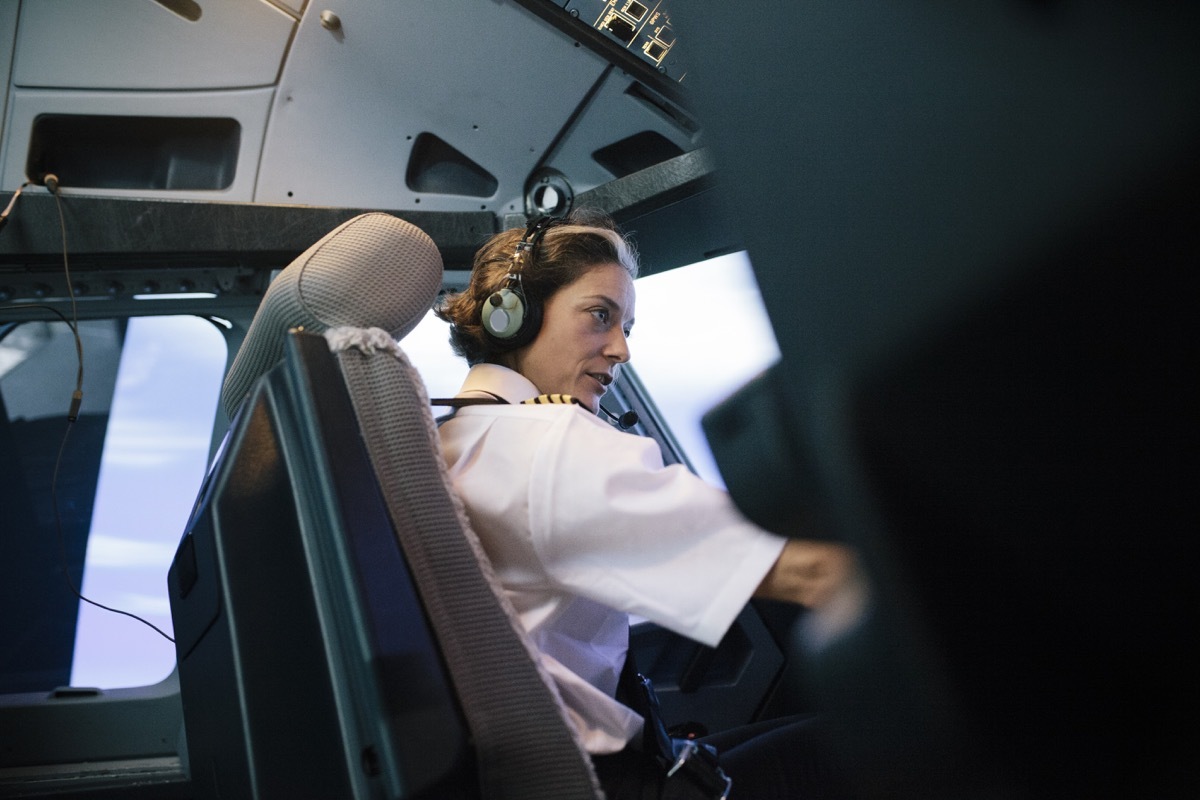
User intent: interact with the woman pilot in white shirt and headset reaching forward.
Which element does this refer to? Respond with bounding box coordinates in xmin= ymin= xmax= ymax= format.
xmin=437 ymin=211 xmax=854 ymax=798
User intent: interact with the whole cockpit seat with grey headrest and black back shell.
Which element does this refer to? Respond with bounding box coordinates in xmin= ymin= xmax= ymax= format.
xmin=170 ymin=212 xmax=602 ymax=800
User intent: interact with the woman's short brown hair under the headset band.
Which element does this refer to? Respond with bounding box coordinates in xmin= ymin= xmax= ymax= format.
xmin=434 ymin=209 xmax=638 ymax=366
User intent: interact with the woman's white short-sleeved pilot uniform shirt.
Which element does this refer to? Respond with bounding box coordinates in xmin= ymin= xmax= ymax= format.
xmin=440 ymin=365 xmax=784 ymax=753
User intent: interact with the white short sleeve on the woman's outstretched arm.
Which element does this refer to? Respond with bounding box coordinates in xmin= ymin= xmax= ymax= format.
xmin=529 ymin=410 xmax=784 ymax=645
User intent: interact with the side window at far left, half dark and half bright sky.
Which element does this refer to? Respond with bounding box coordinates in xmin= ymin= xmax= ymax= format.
xmin=0 ymin=317 xmax=227 ymax=692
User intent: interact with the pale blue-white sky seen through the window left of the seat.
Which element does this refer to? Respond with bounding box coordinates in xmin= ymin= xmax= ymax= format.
xmin=71 ymin=317 xmax=226 ymax=688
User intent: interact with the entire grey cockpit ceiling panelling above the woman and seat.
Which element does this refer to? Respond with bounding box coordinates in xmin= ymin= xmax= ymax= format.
xmin=0 ymin=0 xmax=701 ymax=216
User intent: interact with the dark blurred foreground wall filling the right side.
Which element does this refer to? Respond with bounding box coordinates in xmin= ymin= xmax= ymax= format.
xmin=680 ymin=2 xmax=1200 ymax=799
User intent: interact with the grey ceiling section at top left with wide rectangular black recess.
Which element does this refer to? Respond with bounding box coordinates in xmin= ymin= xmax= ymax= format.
xmin=0 ymin=0 xmax=296 ymax=200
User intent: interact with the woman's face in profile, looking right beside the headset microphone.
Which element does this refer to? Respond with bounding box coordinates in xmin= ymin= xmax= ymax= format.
xmin=509 ymin=263 xmax=635 ymax=411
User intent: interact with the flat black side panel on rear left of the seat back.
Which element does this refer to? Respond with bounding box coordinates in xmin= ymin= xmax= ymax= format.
xmin=169 ymin=393 xmax=348 ymax=798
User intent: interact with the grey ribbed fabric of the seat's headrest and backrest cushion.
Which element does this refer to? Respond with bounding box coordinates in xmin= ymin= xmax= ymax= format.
xmin=222 ymin=213 xmax=602 ymax=800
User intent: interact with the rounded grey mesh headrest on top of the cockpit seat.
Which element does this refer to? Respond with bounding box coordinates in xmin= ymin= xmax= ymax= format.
xmin=221 ymin=212 xmax=442 ymax=417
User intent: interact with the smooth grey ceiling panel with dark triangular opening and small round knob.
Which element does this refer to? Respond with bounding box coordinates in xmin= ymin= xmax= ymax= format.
xmin=254 ymin=0 xmax=608 ymax=213
